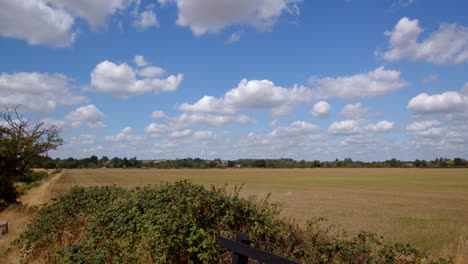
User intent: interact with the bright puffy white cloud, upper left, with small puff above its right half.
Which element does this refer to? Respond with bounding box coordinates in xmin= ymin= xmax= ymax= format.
xmin=91 ymin=58 xmax=183 ymax=98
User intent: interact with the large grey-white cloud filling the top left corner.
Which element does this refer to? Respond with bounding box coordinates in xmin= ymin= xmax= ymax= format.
xmin=0 ymin=0 xmax=135 ymax=47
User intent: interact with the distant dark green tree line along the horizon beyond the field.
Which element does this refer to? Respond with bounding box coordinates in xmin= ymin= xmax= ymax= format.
xmin=34 ymin=155 xmax=468 ymax=169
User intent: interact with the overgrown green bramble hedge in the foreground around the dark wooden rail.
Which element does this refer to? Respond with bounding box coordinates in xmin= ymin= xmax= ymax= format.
xmin=15 ymin=181 xmax=450 ymax=263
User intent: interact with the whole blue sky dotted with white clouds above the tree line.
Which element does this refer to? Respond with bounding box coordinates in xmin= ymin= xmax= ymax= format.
xmin=0 ymin=0 xmax=468 ymax=161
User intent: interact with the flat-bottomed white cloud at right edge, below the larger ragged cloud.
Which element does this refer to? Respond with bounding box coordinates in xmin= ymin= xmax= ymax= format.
xmin=407 ymin=89 xmax=468 ymax=114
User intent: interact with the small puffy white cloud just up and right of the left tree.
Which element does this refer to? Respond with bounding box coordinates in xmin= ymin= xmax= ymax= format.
xmin=65 ymin=104 xmax=106 ymax=128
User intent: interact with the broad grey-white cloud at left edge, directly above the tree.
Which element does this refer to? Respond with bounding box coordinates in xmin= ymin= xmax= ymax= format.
xmin=0 ymin=72 xmax=85 ymax=113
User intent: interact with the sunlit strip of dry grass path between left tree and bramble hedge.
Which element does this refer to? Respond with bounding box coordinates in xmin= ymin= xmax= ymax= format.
xmin=19 ymin=172 xmax=63 ymax=206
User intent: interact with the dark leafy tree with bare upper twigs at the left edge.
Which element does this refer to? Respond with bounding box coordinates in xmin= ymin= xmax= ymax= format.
xmin=0 ymin=107 xmax=63 ymax=208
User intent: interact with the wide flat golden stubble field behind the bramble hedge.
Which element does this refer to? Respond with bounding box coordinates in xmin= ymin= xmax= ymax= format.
xmin=52 ymin=169 xmax=468 ymax=263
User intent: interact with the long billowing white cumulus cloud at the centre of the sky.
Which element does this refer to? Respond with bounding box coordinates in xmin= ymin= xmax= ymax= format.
xmin=178 ymin=79 xmax=312 ymax=116
